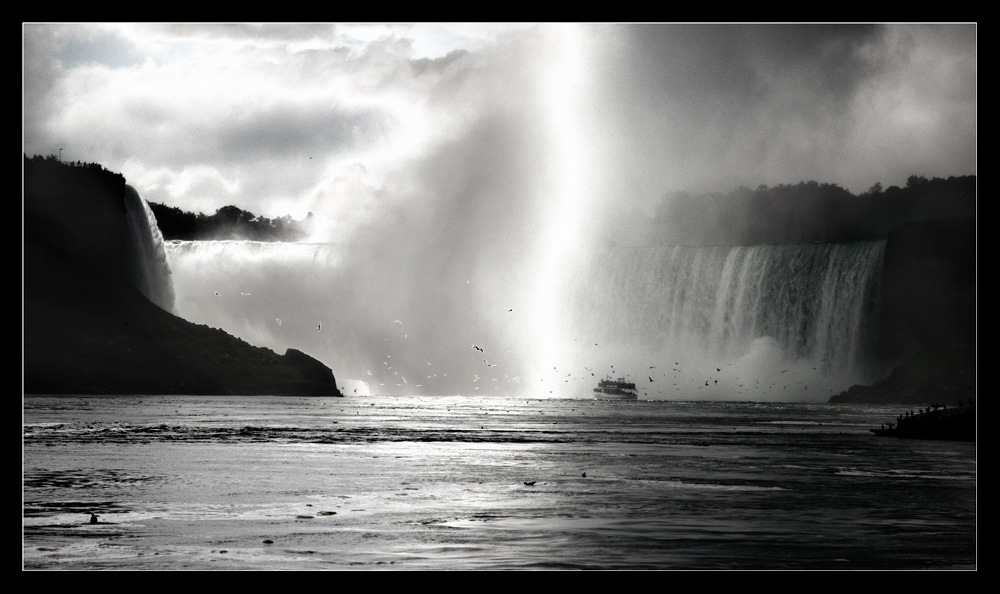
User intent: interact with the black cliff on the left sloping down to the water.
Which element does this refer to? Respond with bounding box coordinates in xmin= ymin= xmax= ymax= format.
xmin=24 ymin=159 xmax=341 ymax=396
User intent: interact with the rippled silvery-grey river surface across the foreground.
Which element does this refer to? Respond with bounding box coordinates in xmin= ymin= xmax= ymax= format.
xmin=22 ymin=396 xmax=976 ymax=569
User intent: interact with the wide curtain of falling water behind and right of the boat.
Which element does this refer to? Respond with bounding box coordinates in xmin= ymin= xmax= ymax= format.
xmin=566 ymin=242 xmax=885 ymax=400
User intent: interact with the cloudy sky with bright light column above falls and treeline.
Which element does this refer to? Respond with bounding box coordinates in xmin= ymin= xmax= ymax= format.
xmin=23 ymin=24 xmax=977 ymax=233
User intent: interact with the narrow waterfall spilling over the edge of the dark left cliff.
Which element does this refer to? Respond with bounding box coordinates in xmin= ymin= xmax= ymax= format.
xmin=125 ymin=185 xmax=176 ymax=313
